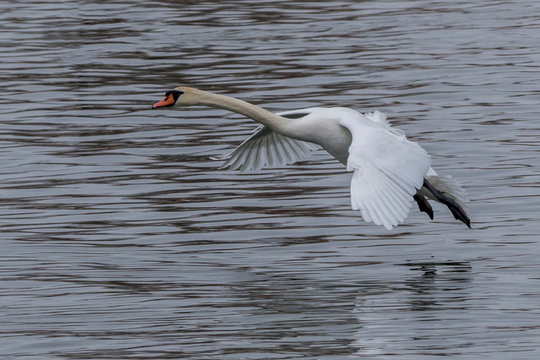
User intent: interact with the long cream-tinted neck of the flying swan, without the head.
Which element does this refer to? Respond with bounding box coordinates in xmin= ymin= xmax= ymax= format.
xmin=192 ymin=89 xmax=291 ymax=133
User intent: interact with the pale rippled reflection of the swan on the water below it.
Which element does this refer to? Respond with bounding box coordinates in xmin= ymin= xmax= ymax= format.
xmin=353 ymin=261 xmax=472 ymax=357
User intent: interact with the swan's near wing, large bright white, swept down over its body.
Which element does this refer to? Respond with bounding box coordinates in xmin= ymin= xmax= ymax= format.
xmin=340 ymin=115 xmax=430 ymax=229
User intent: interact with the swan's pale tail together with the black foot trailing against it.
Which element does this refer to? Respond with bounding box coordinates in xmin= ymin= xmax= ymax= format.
xmin=424 ymin=174 xmax=471 ymax=228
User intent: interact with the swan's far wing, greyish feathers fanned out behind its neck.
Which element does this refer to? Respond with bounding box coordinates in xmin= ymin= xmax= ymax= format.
xmin=211 ymin=108 xmax=318 ymax=171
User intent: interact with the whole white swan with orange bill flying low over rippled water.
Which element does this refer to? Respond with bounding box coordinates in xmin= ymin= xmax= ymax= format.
xmin=152 ymin=86 xmax=471 ymax=230
